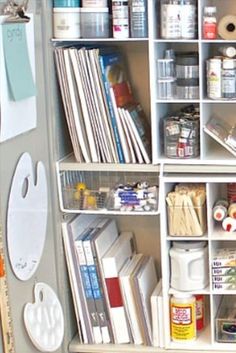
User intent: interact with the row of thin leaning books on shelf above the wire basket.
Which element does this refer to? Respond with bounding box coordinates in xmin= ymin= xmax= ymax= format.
xmin=55 ymin=47 xmax=151 ymax=163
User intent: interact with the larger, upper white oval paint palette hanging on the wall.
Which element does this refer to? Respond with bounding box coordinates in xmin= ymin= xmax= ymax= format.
xmin=7 ymin=152 xmax=48 ymax=281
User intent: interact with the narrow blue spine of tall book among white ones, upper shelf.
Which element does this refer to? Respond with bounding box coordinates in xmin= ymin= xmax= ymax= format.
xmin=99 ymin=55 xmax=125 ymax=163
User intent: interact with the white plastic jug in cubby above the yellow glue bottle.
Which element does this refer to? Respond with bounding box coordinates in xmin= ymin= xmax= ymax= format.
xmin=170 ymin=241 xmax=209 ymax=291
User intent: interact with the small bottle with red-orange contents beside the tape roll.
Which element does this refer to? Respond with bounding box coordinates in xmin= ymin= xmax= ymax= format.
xmin=202 ymin=6 xmax=217 ymax=39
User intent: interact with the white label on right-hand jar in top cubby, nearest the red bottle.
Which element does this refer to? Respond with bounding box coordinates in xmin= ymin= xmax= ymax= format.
xmin=181 ymin=5 xmax=196 ymax=39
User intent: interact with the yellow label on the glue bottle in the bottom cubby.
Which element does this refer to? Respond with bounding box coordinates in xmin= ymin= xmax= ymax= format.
xmin=171 ymin=301 xmax=196 ymax=341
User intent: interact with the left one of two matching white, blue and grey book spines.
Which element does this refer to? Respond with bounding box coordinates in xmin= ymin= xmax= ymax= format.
xmin=75 ymin=240 xmax=102 ymax=343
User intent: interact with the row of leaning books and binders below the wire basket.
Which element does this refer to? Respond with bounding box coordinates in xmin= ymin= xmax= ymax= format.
xmin=62 ymin=215 xmax=163 ymax=346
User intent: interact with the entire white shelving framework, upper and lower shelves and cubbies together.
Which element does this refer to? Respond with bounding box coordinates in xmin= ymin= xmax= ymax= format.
xmin=49 ymin=0 xmax=236 ymax=353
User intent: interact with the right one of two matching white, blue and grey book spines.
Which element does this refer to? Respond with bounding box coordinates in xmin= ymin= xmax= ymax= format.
xmin=83 ymin=236 xmax=111 ymax=343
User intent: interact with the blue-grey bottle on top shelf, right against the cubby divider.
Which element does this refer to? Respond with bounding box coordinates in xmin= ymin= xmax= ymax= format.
xmin=129 ymin=0 xmax=148 ymax=38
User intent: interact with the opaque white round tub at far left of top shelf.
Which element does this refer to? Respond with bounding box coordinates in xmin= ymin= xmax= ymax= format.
xmin=53 ymin=7 xmax=80 ymax=39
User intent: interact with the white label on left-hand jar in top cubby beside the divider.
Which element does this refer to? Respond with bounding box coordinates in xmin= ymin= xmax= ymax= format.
xmin=161 ymin=4 xmax=181 ymax=39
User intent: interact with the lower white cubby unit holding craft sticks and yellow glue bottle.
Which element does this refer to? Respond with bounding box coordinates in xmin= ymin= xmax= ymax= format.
xmin=160 ymin=175 xmax=236 ymax=351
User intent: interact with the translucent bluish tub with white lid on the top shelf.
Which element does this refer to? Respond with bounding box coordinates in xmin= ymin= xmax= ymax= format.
xmin=81 ymin=7 xmax=109 ymax=38
